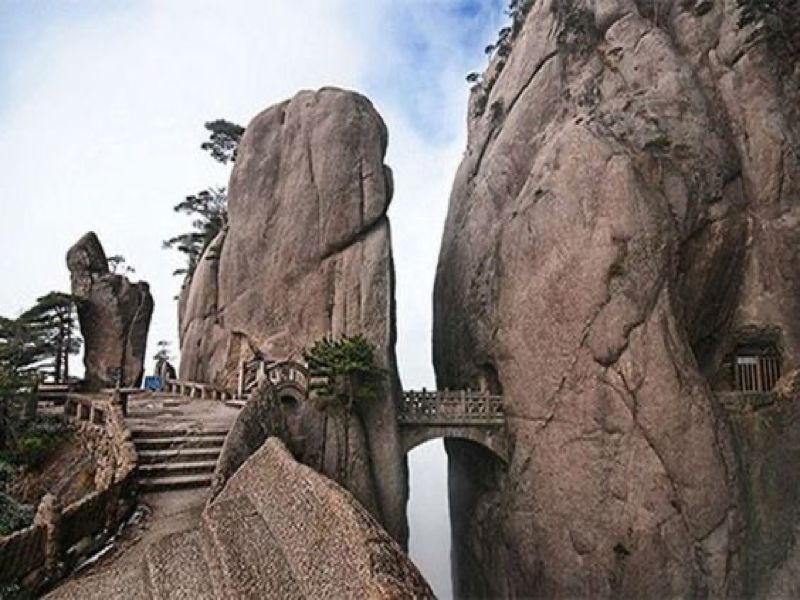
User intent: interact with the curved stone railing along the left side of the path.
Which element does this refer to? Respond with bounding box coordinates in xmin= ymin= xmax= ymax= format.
xmin=0 ymin=393 xmax=138 ymax=593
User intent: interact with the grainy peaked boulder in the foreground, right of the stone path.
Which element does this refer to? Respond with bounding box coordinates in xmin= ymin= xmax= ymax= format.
xmin=203 ymin=438 xmax=433 ymax=598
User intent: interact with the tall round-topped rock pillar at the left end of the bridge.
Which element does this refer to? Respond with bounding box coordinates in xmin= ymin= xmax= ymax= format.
xmin=180 ymin=88 xmax=407 ymax=543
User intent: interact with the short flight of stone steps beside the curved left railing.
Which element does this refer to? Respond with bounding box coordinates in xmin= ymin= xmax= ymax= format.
xmin=132 ymin=427 xmax=228 ymax=492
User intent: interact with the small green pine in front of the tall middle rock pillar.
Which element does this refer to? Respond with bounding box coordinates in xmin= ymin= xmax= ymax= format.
xmin=303 ymin=335 xmax=386 ymax=483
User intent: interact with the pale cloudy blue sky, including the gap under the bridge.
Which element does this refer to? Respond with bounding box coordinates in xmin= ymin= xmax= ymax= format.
xmin=0 ymin=0 xmax=505 ymax=598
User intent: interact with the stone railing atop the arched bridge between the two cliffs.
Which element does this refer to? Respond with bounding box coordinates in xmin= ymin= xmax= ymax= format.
xmin=397 ymin=389 xmax=505 ymax=425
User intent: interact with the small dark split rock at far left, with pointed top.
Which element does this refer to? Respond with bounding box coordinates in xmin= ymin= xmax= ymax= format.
xmin=67 ymin=232 xmax=153 ymax=390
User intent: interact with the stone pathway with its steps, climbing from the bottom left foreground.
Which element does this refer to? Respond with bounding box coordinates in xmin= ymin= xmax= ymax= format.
xmin=47 ymin=394 xmax=239 ymax=599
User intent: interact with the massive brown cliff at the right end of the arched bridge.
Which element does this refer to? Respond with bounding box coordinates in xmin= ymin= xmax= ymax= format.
xmin=434 ymin=0 xmax=800 ymax=597
